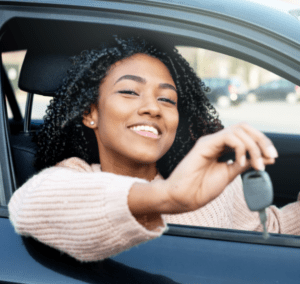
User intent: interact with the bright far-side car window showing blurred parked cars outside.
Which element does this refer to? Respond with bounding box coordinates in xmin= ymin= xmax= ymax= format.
xmin=177 ymin=46 xmax=300 ymax=134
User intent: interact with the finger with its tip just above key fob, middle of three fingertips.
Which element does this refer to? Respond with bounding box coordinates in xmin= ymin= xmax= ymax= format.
xmin=233 ymin=127 xmax=265 ymax=171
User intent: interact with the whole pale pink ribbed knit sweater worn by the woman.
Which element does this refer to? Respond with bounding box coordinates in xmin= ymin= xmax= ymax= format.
xmin=8 ymin=158 xmax=300 ymax=261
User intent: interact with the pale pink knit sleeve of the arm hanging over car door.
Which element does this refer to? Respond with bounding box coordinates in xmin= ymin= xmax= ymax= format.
xmin=8 ymin=167 xmax=166 ymax=261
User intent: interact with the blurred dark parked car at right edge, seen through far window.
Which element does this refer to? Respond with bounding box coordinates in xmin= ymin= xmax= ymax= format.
xmin=246 ymin=79 xmax=300 ymax=104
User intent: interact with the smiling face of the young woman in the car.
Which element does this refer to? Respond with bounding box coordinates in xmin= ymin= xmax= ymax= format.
xmin=92 ymin=54 xmax=179 ymax=163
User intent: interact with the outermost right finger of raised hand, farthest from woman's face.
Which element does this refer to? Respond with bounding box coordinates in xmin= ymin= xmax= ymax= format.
xmin=239 ymin=123 xmax=278 ymax=158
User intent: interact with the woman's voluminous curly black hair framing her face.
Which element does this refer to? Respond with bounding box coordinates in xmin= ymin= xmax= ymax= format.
xmin=35 ymin=36 xmax=223 ymax=178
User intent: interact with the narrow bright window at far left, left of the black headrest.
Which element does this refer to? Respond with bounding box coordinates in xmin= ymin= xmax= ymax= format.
xmin=2 ymin=50 xmax=27 ymax=118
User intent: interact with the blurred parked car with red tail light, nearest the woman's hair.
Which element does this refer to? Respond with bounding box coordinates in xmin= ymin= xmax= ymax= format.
xmin=202 ymin=78 xmax=243 ymax=108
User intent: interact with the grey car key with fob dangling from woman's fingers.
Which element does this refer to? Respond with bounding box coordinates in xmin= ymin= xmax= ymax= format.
xmin=243 ymin=171 xmax=273 ymax=239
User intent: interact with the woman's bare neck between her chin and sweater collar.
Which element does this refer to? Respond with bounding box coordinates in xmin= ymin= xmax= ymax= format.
xmin=100 ymin=154 xmax=157 ymax=181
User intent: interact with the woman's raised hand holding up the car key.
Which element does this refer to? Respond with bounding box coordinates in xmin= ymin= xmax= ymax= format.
xmin=163 ymin=123 xmax=278 ymax=213
